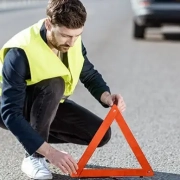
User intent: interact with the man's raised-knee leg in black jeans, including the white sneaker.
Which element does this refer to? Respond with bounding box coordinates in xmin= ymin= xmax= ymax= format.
xmin=21 ymin=78 xmax=65 ymax=179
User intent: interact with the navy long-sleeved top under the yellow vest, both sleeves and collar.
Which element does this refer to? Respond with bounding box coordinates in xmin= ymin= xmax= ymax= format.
xmin=1 ymin=22 xmax=110 ymax=155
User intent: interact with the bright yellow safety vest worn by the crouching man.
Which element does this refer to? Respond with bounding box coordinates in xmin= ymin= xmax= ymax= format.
xmin=0 ymin=19 xmax=84 ymax=102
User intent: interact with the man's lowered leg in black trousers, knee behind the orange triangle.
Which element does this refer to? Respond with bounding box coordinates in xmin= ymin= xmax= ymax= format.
xmin=49 ymin=100 xmax=111 ymax=147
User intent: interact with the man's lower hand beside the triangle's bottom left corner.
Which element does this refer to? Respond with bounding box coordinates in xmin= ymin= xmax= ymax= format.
xmin=37 ymin=142 xmax=78 ymax=174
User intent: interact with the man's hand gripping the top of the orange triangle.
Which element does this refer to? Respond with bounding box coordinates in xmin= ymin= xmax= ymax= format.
xmin=101 ymin=92 xmax=126 ymax=112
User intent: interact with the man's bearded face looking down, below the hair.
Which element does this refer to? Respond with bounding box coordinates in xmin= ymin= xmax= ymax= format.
xmin=46 ymin=20 xmax=83 ymax=53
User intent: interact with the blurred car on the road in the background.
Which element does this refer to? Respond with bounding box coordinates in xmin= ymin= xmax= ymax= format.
xmin=131 ymin=0 xmax=180 ymax=39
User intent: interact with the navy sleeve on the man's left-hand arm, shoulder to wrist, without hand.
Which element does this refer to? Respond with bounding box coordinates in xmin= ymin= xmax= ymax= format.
xmin=1 ymin=48 xmax=44 ymax=155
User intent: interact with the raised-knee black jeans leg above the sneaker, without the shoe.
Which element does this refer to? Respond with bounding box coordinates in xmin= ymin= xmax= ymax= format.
xmin=24 ymin=78 xmax=65 ymax=157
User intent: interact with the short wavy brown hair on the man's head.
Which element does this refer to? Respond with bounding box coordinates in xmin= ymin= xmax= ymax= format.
xmin=46 ymin=0 xmax=87 ymax=29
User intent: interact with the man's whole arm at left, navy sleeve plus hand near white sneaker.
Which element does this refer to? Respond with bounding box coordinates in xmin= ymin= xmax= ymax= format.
xmin=1 ymin=49 xmax=80 ymax=174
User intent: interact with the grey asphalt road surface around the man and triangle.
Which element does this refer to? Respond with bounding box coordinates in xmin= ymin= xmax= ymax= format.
xmin=0 ymin=0 xmax=180 ymax=180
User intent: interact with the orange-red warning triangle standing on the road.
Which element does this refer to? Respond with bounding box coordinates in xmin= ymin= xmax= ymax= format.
xmin=71 ymin=105 xmax=154 ymax=178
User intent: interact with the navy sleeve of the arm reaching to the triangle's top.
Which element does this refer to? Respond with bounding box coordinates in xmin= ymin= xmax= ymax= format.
xmin=80 ymin=43 xmax=111 ymax=107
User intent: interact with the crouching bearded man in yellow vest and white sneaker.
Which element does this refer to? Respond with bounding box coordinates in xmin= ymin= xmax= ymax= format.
xmin=0 ymin=0 xmax=125 ymax=179
